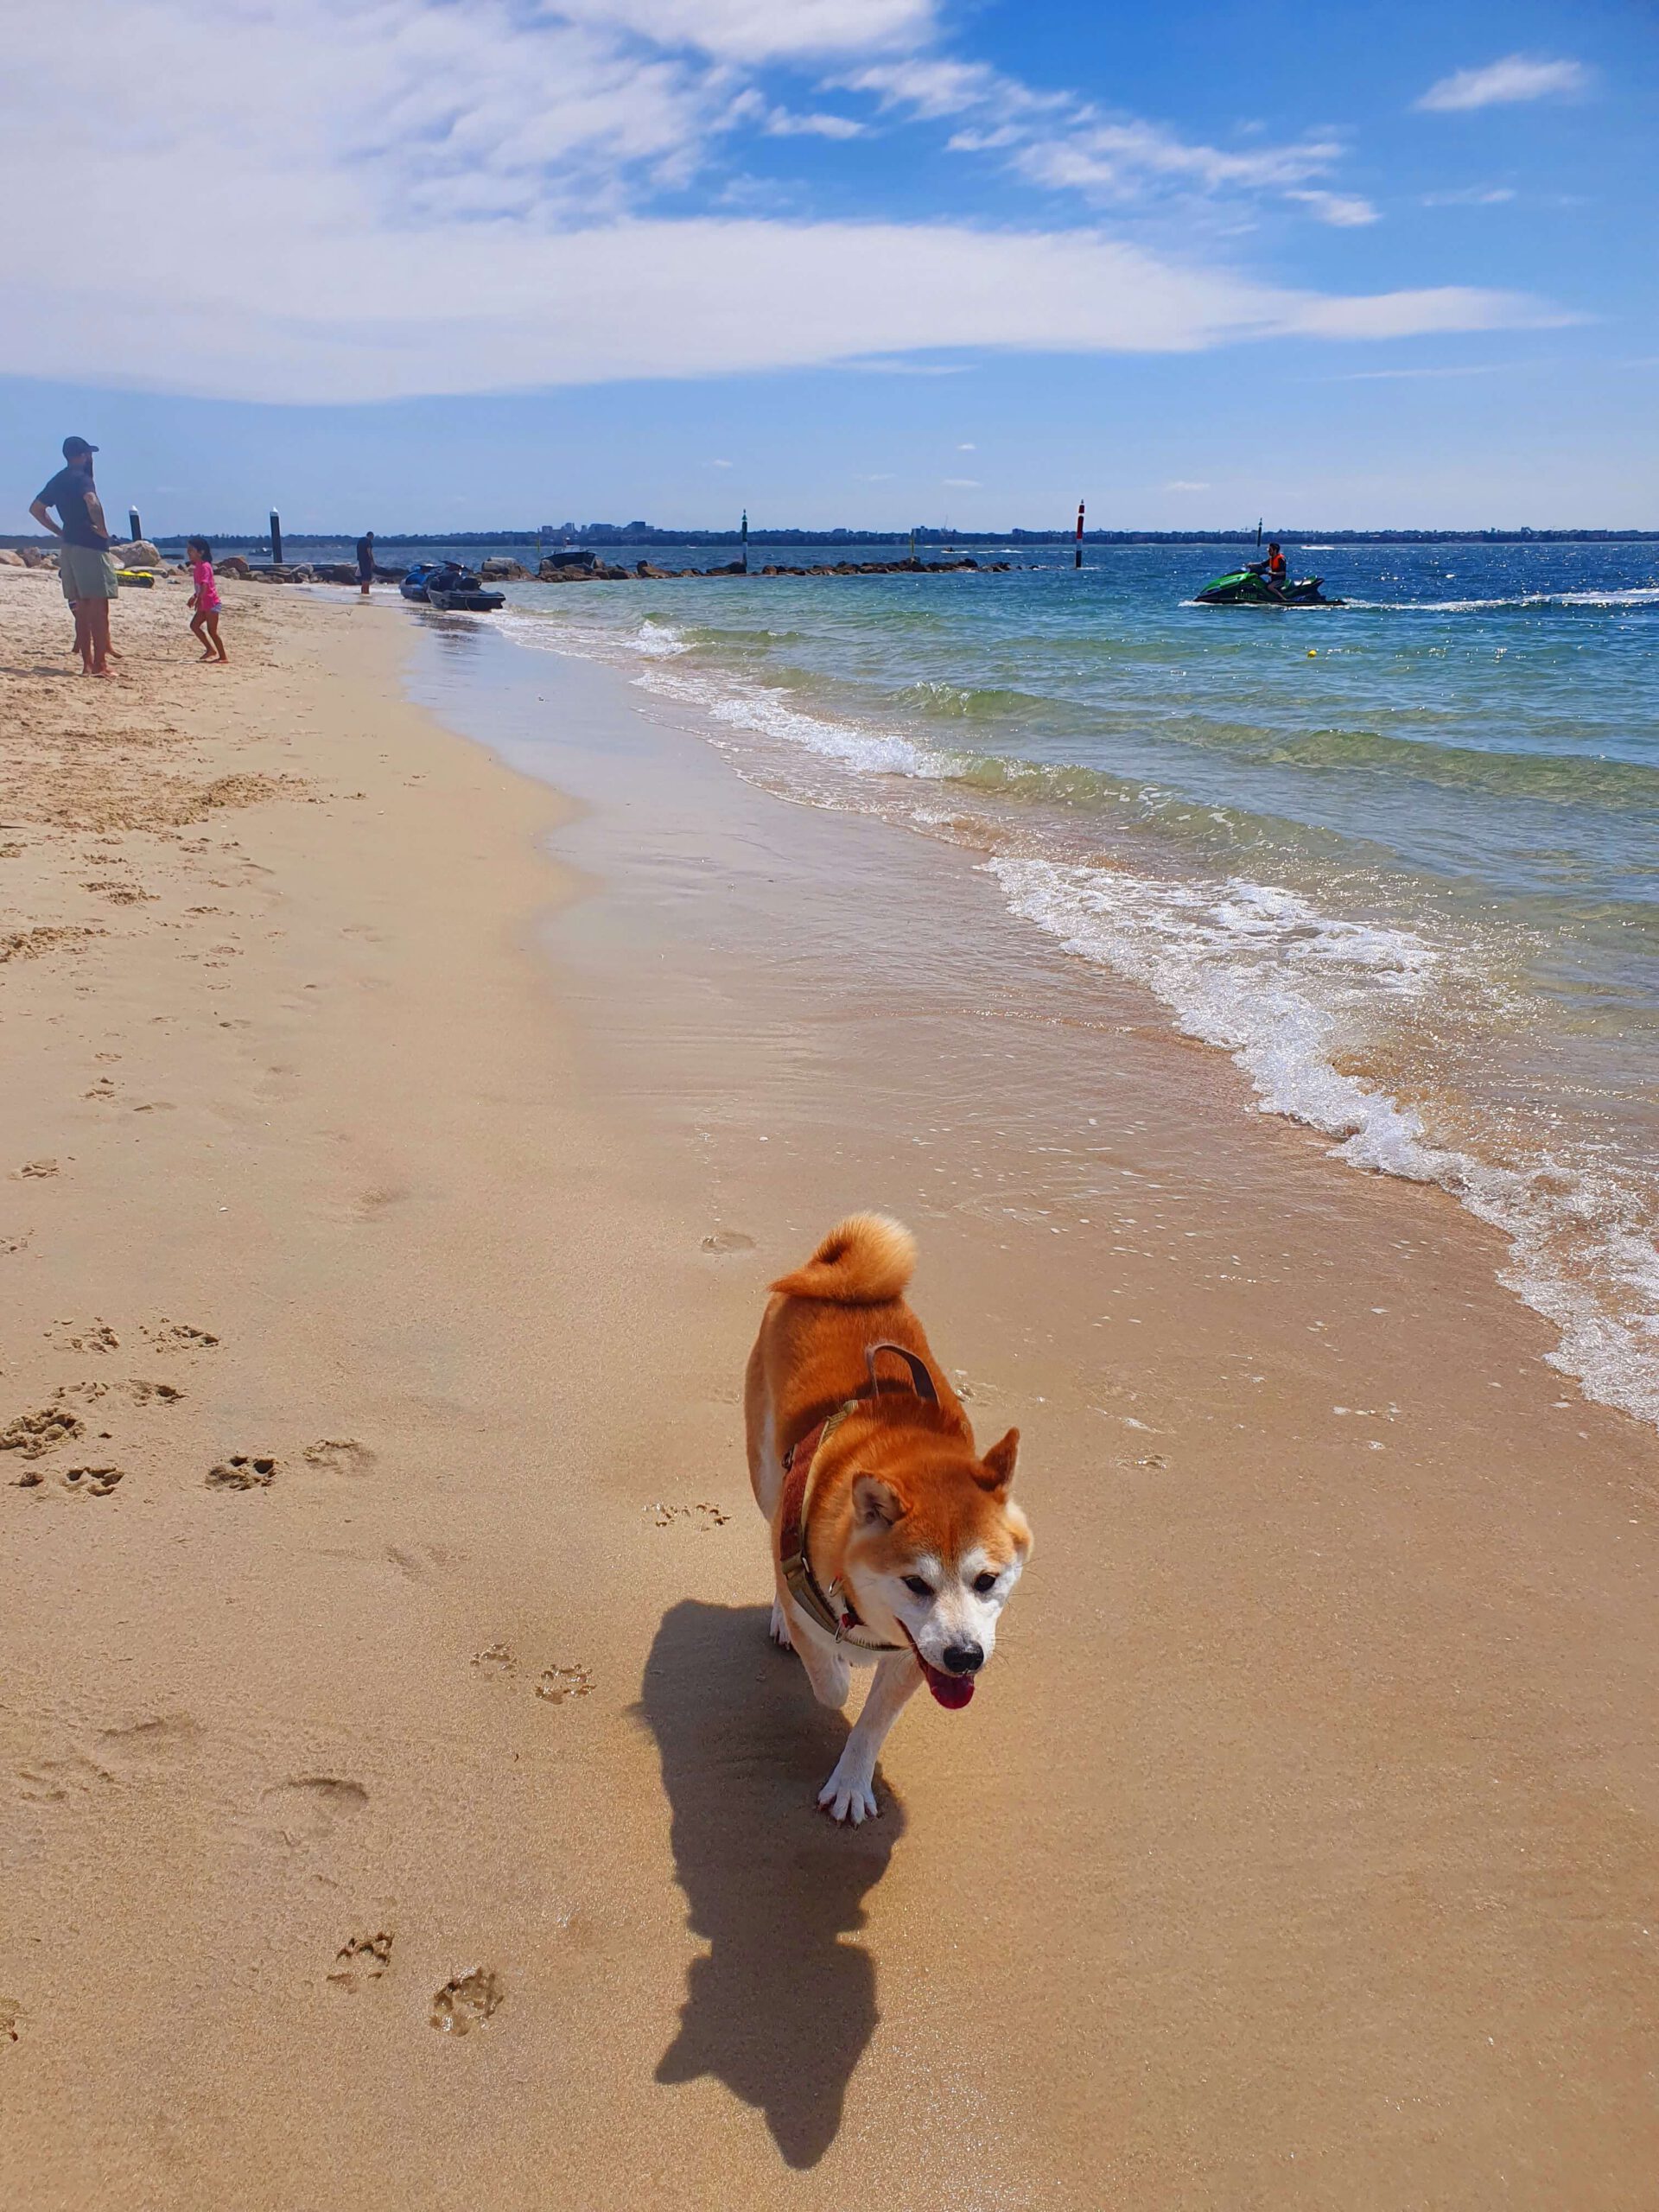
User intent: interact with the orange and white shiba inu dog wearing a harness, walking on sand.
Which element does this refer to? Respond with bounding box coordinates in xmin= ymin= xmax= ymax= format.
xmin=746 ymin=1214 xmax=1031 ymax=1821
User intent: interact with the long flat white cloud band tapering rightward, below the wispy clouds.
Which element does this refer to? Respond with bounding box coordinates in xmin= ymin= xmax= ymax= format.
xmin=0 ymin=200 xmax=1560 ymax=400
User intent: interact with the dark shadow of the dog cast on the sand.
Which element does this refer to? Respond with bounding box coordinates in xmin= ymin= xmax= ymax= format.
xmin=639 ymin=1599 xmax=905 ymax=2168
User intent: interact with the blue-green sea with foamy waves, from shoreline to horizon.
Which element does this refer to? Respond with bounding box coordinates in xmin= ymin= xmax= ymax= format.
xmin=468 ymin=544 xmax=1659 ymax=1421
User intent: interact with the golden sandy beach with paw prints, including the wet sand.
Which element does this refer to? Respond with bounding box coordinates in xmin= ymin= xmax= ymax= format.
xmin=0 ymin=570 xmax=1659 ymax=2212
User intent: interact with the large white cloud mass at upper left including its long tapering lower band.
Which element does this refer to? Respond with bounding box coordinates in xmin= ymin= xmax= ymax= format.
xmin=0 ymin=0 xmax=1561 ymax=403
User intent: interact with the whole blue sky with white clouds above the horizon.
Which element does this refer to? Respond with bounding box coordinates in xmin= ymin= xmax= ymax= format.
xmin=0 ymin=0 xmax=1659 ymax=533
